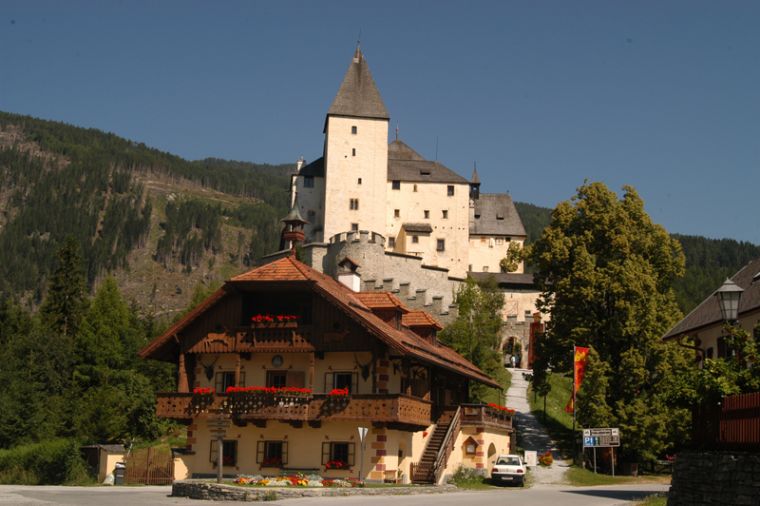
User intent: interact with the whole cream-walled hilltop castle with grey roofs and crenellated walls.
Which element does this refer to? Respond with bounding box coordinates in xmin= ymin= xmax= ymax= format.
xmin=280 ymin=47 xmax=537 ymax=364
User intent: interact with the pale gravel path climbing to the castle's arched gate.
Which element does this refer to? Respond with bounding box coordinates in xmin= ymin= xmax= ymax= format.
xmin=506 ymin=369 xmax=571 ymax=483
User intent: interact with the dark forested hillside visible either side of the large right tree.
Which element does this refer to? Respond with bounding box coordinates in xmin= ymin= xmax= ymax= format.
xmin=515 ymin=202 xmax=760 ymax=314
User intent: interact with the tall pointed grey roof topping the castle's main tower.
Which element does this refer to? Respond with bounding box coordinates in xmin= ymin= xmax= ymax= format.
xmin=327 ymin=45 xmax=390 ymax=119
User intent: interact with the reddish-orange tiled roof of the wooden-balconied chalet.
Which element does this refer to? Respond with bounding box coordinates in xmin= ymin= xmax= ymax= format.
xmin=140 ymin=256 xmax=501 ymax=388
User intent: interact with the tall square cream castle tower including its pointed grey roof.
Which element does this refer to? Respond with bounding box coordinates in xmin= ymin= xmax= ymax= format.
xmin=322 ymin=46 xmax=389 ymax=241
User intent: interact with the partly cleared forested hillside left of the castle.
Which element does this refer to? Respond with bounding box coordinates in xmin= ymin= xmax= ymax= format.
xmin=0 ymin=113 xmax=290 ymax=314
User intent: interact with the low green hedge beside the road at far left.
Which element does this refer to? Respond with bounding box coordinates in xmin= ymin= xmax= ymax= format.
xmin=0 ymin=439 xmax=92 ymax=485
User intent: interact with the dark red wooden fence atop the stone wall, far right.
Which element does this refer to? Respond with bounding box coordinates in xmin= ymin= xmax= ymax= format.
xmin=692 ymin=392 xmax=760 ymax=450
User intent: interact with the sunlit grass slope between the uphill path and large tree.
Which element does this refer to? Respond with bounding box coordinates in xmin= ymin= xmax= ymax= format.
xmin=528 ymin=373 xmax=575 ymax=457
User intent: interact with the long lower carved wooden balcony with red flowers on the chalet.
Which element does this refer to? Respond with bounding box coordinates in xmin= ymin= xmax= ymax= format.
xmin=156 ymin=393 xmax=432 ymax=427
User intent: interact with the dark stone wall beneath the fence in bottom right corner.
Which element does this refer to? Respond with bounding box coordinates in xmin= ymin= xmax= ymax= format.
xmin=668 ymin=451 xmax=760 ymax=506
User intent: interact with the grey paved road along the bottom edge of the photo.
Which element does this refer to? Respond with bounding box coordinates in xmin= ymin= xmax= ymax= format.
xmin=0 ymin=484 xmax=668 ymax=506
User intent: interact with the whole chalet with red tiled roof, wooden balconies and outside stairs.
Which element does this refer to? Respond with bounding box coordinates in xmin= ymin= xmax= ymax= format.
xmin=140 ymin=255 xmax=512 ymax=483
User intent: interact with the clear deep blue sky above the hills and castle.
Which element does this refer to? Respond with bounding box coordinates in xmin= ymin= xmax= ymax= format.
xmin=0 ymin=0 xmax=760 ymax=243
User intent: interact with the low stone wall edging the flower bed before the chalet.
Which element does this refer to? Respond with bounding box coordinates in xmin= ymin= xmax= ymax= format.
xmin=172 ymin=480 xmax=458 ymax=501
